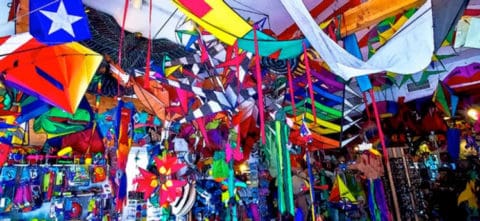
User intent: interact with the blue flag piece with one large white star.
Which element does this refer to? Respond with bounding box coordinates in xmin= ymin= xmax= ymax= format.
xmin=29 ymin=0 xmax=91 ymax=45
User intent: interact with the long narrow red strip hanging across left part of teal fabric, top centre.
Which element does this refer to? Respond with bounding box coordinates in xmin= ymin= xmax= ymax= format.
xmin=253 ymin=26 xmax=266 ymax=144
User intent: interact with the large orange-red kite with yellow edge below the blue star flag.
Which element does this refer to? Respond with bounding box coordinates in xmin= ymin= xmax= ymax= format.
xmin=0 ymin=33 xmax=102 ymax=113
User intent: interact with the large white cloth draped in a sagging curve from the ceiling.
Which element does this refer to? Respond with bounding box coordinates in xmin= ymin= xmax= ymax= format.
xmin=281 ymin=0 xmax=434 ymax=80
